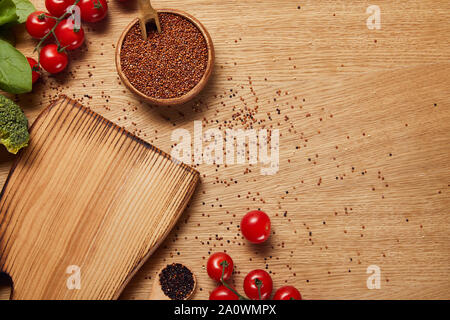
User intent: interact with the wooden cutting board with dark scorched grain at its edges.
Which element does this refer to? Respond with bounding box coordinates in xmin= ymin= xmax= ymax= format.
xmin=0 ymin=98 xmax=199 ymax=299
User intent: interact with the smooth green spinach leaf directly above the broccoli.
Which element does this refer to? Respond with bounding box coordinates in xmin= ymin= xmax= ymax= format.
xmin=0 ymin=39 xmax=32 ymax=93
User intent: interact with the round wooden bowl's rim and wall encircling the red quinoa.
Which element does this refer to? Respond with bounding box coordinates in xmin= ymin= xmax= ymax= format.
xmin=116 ymin=9 xmax=214 ymax=106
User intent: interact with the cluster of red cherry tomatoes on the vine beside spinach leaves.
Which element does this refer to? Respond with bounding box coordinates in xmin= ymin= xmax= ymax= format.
xmin=25 ymin=0 xmax=108 ymax=79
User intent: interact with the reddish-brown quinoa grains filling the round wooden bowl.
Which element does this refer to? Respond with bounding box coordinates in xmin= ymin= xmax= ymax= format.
xmin=120 ymin=12 xmax=208 ymax=99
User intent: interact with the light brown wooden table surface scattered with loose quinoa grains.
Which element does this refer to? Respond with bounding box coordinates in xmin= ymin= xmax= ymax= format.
xmin=0 ymin=0 xmax=450 ymax=299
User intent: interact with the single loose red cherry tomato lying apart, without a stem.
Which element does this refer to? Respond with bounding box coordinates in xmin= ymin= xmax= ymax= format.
xmin=241 ymin=210 xmax=270 ymax=243
